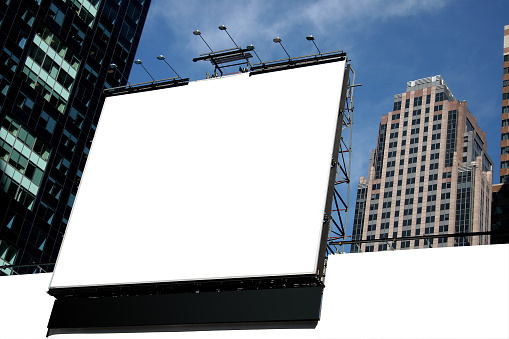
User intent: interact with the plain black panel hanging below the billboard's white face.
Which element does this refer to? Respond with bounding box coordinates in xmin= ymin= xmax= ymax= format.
xmin=48 ymin=287 xmax=322 ymax=335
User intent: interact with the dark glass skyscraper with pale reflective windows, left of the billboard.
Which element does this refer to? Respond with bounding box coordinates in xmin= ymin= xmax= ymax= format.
xmin=0 ymin=0 xmax=150 ymax=275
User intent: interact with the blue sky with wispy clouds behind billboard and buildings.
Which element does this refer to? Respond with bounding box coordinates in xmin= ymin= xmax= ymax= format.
xmin=130 ymin=0 xmax=509 ymax=247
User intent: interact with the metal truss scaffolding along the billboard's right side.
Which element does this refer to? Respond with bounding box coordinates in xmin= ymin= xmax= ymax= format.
xmin=327 ymin=66 xmax=361 ymax=255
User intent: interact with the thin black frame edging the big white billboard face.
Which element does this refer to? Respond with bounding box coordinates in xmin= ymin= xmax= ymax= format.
xmin=48 ymin=56 xmax=350 ymax=298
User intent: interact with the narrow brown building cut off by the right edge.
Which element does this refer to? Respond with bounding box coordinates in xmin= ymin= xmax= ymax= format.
xmin=491 ymin=25 xmax=509 ymax=244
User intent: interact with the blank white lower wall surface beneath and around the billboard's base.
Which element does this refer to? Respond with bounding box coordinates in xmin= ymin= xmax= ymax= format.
xmin=0 ymin=244 xmax=509 ymax=339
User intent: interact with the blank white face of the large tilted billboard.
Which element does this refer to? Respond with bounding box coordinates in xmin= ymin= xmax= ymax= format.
xmin=50 ymin=61 xmax=345 ymax=288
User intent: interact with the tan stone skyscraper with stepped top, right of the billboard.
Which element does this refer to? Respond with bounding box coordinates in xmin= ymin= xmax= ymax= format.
xmin=351 ymin=75 xmax=492 ymax=252
